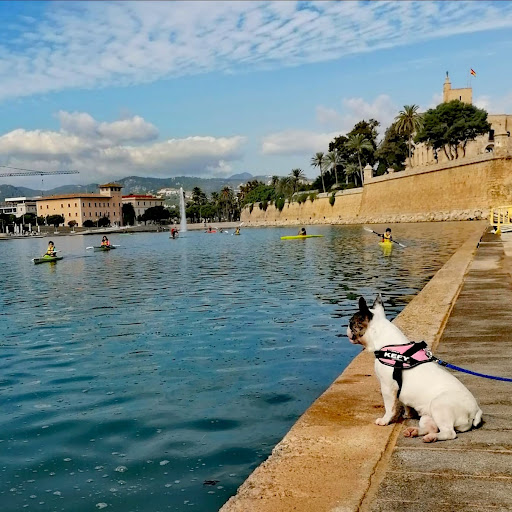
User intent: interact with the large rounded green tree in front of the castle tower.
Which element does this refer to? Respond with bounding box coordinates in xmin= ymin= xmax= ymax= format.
xmin=415 ymin=100 xmax=491 ymax=160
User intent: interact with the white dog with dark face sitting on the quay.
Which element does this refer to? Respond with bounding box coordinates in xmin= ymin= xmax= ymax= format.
xmin=347 ymin=294 xmax=482 ymax=443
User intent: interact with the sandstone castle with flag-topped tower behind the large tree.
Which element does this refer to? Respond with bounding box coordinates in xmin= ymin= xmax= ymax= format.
xmin=407 ymin=73 xmax=512 ymax=167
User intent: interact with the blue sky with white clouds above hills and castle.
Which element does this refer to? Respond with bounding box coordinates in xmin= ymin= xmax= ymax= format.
xmin=0 ymin=0 xmax=512 ymax=188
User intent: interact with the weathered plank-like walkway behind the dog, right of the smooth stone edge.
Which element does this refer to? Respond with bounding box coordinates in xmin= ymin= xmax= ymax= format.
xmin=361 ymin=230 xmax=512 ymax=512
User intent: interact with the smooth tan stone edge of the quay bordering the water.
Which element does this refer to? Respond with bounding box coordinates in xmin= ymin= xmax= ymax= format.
xmin=221 ymin=222 xmax=485 ymax=512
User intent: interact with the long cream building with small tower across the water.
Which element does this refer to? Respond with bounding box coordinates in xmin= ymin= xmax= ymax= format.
xmin=37 ymin=183 xmax=123 ymax=227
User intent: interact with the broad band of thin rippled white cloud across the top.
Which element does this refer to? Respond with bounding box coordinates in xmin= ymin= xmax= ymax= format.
xmin=0 ymin=1 xmax=512 ymax=100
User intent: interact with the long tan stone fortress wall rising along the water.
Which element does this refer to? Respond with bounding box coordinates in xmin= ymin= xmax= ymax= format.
xmin=241 ymin=153 xmax=512 ymax=226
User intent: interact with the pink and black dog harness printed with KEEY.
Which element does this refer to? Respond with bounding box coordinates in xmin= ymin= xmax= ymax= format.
xmin=374 ymin=341 xmax=433 ymax=398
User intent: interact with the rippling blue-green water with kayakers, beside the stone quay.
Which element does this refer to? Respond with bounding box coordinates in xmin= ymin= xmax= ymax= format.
xmin=0 ymin=223 xmax=474 ymax=512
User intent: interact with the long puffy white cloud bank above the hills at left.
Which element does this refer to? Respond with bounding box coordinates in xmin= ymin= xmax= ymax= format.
xmin=0 ymin=111 xmax=245 ymax=180
